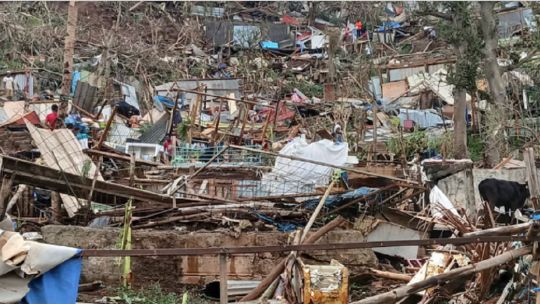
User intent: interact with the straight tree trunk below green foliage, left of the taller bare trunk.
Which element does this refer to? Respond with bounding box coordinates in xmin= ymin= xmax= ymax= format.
xmin=454 ymin=88 xmax=468 ymax=159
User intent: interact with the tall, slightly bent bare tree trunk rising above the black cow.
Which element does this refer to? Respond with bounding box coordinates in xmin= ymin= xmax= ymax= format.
xmin=478 ymin=2 xmax=509 ymax=168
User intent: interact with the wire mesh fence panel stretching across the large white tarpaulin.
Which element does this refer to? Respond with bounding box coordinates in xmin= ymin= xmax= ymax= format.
xmin=181 ymin=146 xmax=347 ymax=200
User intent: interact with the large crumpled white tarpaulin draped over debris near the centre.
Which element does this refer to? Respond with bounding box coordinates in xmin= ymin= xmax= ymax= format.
xmin=261 ymin=136 xmax=349 ymax=196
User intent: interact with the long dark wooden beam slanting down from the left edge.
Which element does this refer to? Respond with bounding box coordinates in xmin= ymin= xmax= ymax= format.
xmin=0 ymin=155 xmax=197 ymax=206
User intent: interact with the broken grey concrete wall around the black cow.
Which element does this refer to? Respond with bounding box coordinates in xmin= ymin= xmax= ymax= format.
xmin=437 ymin=168 xmax=527 ymax=213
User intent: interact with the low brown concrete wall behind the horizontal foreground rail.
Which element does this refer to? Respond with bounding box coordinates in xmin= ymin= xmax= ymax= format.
xmin=42 ymin=225 xmax=377 ymax=289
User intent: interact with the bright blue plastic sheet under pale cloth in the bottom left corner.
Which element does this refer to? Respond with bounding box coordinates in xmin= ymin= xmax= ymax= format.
xmin=21 ymin=250 xmax=82 ymax=304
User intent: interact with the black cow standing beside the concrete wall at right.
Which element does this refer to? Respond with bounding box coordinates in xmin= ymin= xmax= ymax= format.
xmin=478 ymin=178 xmax=530 ymax=223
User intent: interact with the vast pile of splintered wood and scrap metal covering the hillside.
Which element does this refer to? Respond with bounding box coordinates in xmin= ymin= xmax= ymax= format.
xmin=0 ymin=3 xmax=540 ymax=303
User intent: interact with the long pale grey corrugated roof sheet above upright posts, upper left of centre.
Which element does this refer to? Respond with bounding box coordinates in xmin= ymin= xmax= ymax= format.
xmin=156 ymin=79 xmax=241 ymax=104
